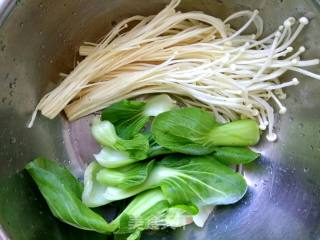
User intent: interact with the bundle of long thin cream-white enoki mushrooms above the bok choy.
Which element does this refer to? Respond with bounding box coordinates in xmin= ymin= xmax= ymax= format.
xmin=29 ymin=0 xmax=320 ymax=141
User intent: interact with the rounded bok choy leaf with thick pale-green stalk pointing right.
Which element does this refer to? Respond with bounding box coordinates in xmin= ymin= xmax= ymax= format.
xmin=151 ymin=108 xmax=259 ymax=155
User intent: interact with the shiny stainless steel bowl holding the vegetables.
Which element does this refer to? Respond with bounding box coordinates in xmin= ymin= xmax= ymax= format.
xmin=0 ymin=0 xmax=320 ymax=240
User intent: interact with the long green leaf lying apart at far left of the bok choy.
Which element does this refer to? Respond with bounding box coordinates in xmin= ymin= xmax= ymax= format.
xmin=26 ymin=158 xmax=116 ymax=233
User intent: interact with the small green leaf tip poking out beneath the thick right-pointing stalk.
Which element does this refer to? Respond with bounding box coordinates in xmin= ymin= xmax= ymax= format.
xmin=212 ymin=147 xmax=260 ymax=165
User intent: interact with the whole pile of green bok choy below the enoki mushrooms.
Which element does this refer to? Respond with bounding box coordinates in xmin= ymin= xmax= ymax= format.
xmin=26 ymin=95 xmax=259 ymax=240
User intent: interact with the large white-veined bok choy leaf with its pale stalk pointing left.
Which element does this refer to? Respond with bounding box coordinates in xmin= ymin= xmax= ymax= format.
xmin=84 ymin=155 xmax=247 ymax=207
